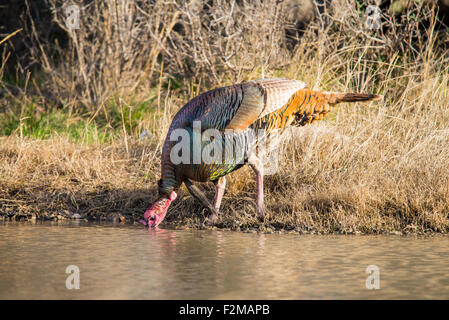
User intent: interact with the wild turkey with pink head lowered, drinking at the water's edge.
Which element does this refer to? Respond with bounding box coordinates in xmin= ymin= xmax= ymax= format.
xmin=141 ymin=79 xmax=379 ymax=227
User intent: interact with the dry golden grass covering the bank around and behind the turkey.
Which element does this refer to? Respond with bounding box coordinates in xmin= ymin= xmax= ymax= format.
xmin=0 ymin=1 xmax=449 ymax=233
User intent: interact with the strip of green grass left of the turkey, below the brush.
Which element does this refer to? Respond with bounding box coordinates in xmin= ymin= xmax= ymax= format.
xmin=0 ymin=95 xmax=164 ymax=144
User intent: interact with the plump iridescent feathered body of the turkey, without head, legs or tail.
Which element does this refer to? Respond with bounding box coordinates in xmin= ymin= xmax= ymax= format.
xmin=160 ymin=79 xmax=310 ymax=194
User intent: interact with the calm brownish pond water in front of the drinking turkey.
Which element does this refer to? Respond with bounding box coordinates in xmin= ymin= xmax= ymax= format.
xmin=0 ymin=222 xmax=449 ymax=299
